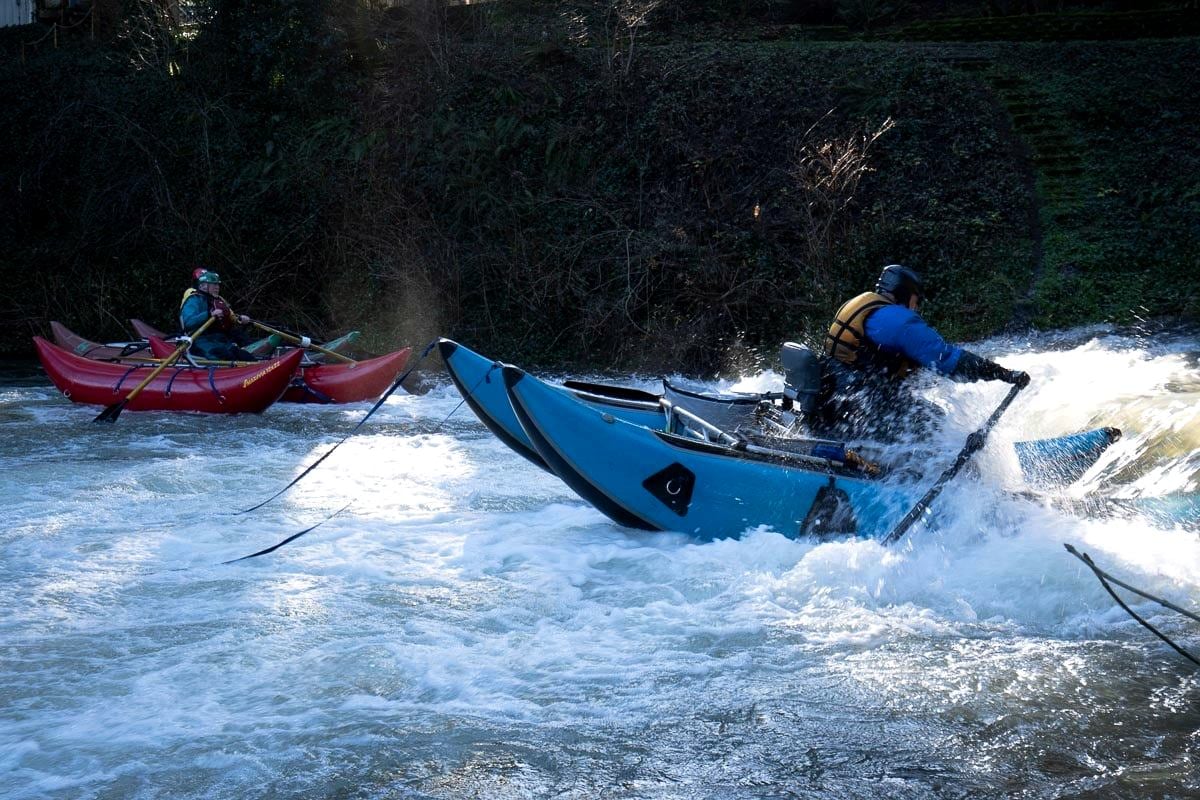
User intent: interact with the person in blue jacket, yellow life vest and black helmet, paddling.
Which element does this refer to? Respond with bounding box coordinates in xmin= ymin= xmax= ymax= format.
xmin=815 ymin=264 xmax=1030 ymax=438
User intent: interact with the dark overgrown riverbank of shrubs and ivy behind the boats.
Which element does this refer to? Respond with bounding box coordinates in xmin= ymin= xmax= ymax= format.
xmin=0 ymin=0 xmax=1200 ymax=369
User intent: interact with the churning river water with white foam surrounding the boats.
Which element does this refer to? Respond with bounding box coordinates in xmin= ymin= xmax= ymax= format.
xmin=0 ymin=329 xmax=1200 ymax=799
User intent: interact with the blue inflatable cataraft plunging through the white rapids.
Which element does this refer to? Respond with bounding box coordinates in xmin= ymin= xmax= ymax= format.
xmin=440 ymin=339 xmax=1120 ymax=539
